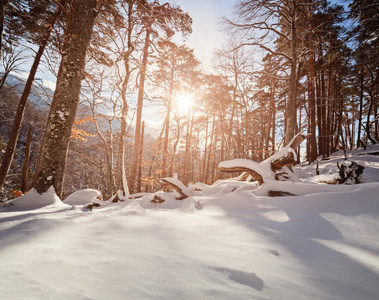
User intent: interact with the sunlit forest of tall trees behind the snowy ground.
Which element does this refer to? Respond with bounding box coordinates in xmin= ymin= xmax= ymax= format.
xmin=0 ymin=0 xmax=379 ymax=201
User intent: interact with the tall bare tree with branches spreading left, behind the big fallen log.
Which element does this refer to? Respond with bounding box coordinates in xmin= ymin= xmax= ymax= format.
xmin=225 ymin=0 xmax=304 ymax=143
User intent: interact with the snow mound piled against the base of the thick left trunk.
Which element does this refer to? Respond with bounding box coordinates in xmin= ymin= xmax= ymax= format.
xmin=2 ymin=186 xmax=68 ymax=210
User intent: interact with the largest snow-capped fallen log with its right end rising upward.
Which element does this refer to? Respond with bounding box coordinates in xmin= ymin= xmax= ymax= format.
xmin=218 ymin=133 xmax=310 ymax=185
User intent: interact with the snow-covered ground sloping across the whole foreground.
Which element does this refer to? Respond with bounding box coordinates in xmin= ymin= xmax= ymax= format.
xmin=0 ymin=148 xmax=379 ymax=300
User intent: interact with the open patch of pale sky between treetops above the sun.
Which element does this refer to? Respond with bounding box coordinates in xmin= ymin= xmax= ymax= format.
xmin=171 ymin=0 xmax=238 ymax=68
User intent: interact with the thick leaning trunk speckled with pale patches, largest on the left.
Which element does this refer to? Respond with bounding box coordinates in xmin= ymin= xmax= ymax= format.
xmin=34 ymin=0 xmax=96 ymax=197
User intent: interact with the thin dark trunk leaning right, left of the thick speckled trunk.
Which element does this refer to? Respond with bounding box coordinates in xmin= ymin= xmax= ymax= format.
xmin=0 ymin=8 xmax=61 ymax=190
